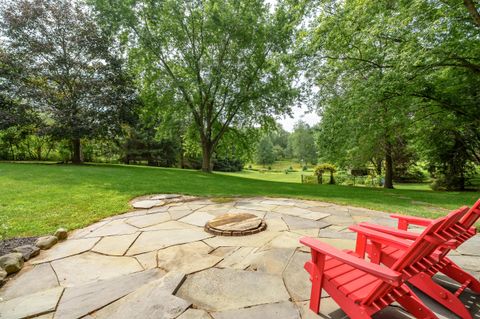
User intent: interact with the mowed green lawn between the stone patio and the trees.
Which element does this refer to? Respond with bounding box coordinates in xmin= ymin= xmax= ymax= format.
xmin=0 ymin=163 xmax=480 ymax=237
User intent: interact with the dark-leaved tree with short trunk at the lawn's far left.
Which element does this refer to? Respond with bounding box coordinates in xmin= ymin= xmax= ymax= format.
xmin=0 ymin=0 xmax=135 ymax=163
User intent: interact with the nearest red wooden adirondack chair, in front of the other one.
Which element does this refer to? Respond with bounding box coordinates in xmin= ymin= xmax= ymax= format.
xmin=300 ymin=210 xmax=466 ymax=319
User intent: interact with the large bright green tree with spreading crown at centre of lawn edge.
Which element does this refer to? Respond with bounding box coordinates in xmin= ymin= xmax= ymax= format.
xmin=92 ymin=0 xmax=305 ymax=172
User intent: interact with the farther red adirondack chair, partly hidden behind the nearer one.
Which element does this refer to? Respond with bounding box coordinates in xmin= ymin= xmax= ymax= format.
xmin=350 ymin=199 xmax=480 ymax=319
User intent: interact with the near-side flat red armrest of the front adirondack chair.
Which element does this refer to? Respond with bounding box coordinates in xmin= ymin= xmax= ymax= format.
xmin=300 ymin=237 xmax=402 ymax=286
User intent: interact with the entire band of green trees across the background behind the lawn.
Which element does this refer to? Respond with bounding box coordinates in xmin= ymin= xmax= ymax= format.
xmin=0 ymin=0 xmax=480 ymax=190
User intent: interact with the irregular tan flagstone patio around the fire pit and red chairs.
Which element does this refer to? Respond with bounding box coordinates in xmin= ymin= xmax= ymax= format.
xmin=0 ymin=195 xmax=480 ymax=319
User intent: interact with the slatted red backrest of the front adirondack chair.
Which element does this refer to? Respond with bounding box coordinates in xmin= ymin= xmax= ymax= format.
xmin=362 ymin=207 xmax=468 ymax=308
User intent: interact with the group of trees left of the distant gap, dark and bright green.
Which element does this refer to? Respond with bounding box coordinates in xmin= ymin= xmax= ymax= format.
xmin=0 ymin=0 xmax=308 ymax=172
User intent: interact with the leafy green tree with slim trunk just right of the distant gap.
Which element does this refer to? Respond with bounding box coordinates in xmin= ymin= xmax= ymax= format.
xmin=310 ymin=1 xmax=416 ymax=188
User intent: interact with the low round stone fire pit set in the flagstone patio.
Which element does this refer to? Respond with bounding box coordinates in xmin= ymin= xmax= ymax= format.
xmin=205 ymin=213 xmax=267 ymax=236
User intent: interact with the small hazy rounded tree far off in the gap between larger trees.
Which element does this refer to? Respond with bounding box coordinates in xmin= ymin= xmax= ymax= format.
xmin=288 ymin=121 xmax=317 ymax=164
